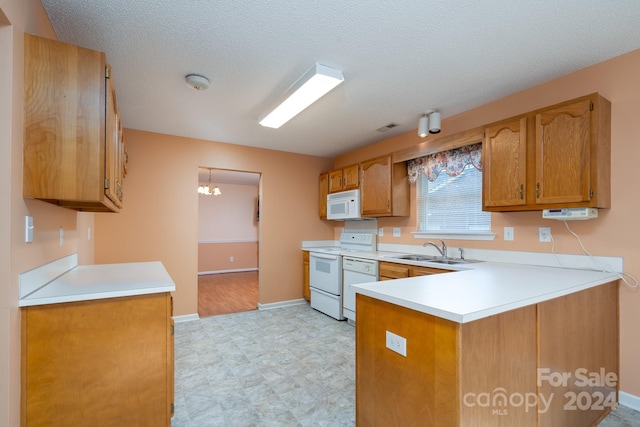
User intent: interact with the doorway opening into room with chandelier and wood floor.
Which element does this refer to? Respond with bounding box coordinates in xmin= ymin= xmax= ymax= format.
xmin=198 ymin=166 xmax=260 ymax=317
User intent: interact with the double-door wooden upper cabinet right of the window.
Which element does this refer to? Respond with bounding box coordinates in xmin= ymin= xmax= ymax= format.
xmin=482 ymin=93 xmax=611 ymax=211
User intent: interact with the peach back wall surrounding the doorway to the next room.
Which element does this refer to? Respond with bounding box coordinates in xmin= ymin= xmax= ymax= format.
xmin=95 ymin=130 xmax=334 ymax=315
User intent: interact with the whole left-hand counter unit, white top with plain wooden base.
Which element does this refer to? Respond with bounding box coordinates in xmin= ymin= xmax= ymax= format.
xmin=19 ymin=256 xmax=175 ymax=426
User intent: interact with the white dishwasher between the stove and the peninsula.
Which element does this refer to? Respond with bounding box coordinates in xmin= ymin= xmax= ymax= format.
xmin=342 ymin=256 xmax=379 ymax=324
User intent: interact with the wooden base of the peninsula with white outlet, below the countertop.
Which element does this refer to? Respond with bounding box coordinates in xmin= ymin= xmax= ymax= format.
xmin=356 ymin=282 xmax=619 ymax=427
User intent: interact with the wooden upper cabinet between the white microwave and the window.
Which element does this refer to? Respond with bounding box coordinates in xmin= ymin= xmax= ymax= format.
xmin=360 ymin=155 xmax=409 ymax=217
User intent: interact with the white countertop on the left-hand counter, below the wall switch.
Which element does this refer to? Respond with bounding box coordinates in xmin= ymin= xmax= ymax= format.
xmin=18 ymin=261 xmax=176 ymax=307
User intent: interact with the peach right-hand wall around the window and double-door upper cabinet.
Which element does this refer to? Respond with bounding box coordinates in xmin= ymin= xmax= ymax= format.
xmin=335 ymin=50 xmax=640 ymax=396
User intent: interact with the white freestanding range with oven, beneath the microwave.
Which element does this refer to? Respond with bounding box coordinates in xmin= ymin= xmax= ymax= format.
xmin=309 ymin=231 xmax=377 ymax=320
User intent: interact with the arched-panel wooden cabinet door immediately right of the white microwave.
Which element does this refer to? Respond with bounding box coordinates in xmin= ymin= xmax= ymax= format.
xmin=360 ymin=156 xmax=392 ymax=216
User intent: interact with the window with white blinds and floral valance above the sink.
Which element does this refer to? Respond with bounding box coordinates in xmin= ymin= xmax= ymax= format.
xmin=409 ymin=144 xmax=493 ymax=239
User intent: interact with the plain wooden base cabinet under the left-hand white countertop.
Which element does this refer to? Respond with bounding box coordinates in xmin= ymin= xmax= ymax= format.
xmin=21 ymin=293 xmax=174 ymax=427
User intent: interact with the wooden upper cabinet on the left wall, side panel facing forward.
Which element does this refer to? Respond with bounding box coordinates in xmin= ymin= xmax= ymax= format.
xmin=23 ymin=34 xmax=126 ymax=212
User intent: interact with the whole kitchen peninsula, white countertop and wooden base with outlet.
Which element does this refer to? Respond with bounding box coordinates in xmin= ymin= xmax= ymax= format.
xmin=355 ymin=262 xmax=619 ymax=426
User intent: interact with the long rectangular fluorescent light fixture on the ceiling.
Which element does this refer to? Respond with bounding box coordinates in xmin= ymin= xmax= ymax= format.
xmin=260 ymin=64 xmax=344 ymax=129
